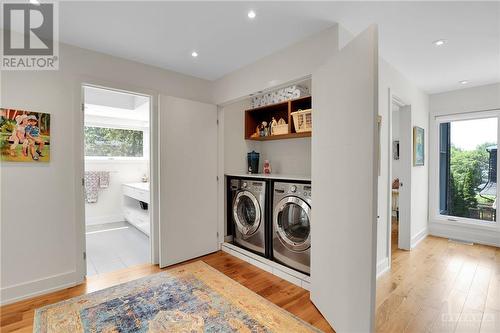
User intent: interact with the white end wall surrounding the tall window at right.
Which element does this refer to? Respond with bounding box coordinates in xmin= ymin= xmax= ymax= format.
xmin=429 ymin=83 xmax=500 ymax=246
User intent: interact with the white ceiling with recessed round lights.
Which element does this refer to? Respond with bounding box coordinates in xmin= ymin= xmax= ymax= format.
xmin=59 ymin=1 xmax=500 ymax=93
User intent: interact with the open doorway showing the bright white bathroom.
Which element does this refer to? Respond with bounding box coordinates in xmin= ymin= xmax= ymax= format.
xmin=83 ymin=86 xmax=153 ymax=276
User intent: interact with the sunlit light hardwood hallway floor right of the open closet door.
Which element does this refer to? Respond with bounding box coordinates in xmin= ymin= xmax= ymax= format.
xmin=376 ymin=235 xmax=500 ymax=332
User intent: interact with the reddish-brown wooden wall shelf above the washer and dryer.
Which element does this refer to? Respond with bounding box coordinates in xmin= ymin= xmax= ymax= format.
xmin=245 ymin=96 xmax=312 ymax=141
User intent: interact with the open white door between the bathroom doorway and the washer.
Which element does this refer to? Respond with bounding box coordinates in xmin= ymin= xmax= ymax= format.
xmin=159 ymin=96 xmax=218 ymax=267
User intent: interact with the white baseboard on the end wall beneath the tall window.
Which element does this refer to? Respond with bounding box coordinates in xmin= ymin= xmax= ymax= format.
xmin=429 ymin=222 xmax=500 ymax=247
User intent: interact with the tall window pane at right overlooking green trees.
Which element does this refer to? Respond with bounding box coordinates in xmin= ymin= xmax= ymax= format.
xmin=439 ymin=117 xmax=498 ymax=222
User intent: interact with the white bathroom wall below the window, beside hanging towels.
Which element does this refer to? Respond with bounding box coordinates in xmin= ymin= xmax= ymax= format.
xmin=85 ymin=159 xmax=149 ymax=225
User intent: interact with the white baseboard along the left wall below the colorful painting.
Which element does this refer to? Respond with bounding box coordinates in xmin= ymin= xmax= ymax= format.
xmin=0 ymin=271 xmax=83 ymax=305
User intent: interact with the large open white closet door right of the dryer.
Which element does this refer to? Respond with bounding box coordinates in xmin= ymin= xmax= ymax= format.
xmin=311 ymin=26 xmax=378 ymax=332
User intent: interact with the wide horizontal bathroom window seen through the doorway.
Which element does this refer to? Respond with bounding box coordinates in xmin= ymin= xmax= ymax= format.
xmin=84 ymin=126 xmax=145 ymax=158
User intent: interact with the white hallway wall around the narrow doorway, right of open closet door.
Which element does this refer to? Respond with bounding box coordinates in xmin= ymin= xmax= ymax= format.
xmin=377 ymin=59 xmax=429 ymax=274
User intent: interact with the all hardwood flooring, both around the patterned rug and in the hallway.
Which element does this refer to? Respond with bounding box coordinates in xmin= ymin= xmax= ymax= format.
xmin=0 ymin=236 xmax=500 ymax=333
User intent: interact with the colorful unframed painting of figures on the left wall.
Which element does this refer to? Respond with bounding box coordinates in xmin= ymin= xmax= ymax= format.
xmin=0 ymin=108 xmax=50 ymax=162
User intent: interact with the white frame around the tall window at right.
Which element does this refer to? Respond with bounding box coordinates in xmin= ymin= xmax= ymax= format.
xmin=429 ymin=110 xmax=500 ymax=231
